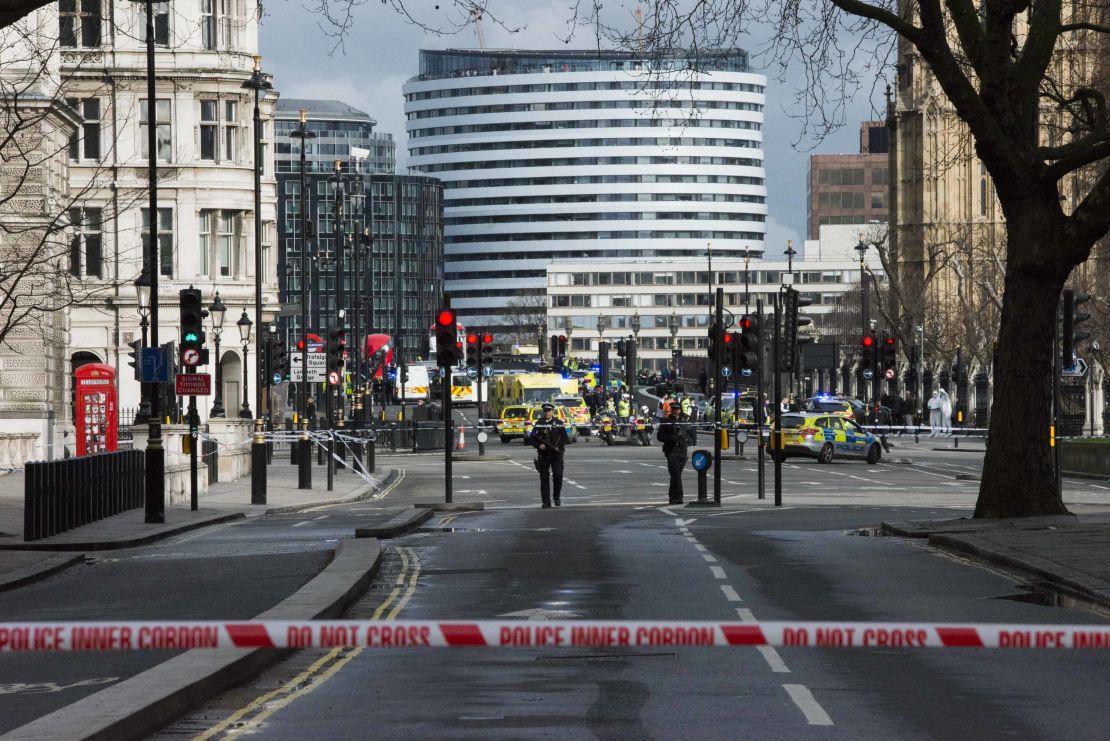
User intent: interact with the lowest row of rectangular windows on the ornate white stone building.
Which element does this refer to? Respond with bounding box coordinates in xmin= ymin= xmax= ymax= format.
xmin=69 ymin=207 xmax=242 ymax=277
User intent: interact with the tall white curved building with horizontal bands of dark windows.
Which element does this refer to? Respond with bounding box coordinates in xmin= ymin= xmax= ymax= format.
xmin=404 ymin=50 xmax=767 ymax=335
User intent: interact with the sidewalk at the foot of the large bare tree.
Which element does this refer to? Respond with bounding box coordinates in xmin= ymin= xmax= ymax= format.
xmin=882 ymin=515 xmax=1110 ymax=609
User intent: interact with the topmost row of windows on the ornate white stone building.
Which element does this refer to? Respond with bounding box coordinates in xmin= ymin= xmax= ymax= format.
xmin=58 ymin=0 xmax=238 ymax=51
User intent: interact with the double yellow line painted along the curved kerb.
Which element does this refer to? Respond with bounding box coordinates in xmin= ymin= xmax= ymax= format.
xmin=193 ymin=548 xmax=420 ymax=741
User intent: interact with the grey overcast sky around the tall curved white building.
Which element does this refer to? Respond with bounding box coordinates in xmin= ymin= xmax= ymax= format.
xmin=261 ymin=0 xmax=874 ymax=258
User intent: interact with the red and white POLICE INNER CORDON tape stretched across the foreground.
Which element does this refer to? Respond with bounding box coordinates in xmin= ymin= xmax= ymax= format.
xmin=0 ymin=620 xmax=1110 ymax=653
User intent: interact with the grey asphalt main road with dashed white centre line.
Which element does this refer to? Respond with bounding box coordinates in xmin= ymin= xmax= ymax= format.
xmin=154 ymin=438 xmax=1110 ymax=739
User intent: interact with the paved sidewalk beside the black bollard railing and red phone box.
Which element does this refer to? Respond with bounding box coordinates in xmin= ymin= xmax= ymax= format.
xmin=0 ymin=457 xmax=393 ymax=590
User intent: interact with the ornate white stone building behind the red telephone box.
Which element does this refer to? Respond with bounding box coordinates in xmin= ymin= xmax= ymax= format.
xmin=59 ymin=0 xmax=278 ymax=439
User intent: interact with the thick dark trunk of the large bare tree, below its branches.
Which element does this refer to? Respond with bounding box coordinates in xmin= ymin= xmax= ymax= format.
xmin=975 ymin=214 xmax=1068 ymax=518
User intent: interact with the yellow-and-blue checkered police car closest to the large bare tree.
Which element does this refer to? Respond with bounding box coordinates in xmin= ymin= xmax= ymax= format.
xmin=768 ymin=413 xmax=882 ymax=465
